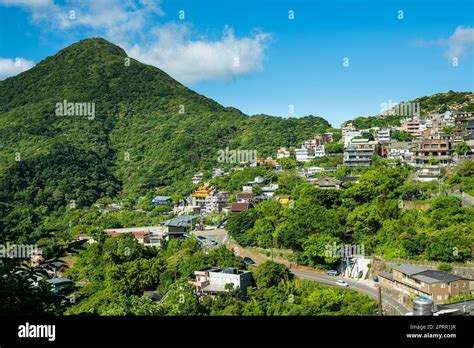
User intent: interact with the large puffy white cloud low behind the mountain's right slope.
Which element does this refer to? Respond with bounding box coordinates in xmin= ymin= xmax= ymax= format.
xmin=127 ymin=24 xmax=271 ymax=83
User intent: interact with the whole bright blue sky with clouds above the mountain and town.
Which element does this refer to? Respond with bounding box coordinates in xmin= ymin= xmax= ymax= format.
xmin=0 ymin=0 xmax=474 ymax=126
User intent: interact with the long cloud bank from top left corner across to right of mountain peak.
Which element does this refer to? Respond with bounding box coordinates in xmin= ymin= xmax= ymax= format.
xmin=0 ymin=0 xmax=270 ymax=83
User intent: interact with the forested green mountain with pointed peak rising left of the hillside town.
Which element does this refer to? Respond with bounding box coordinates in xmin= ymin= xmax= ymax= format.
xmin=0 ymin=38 xmax=330 ymax=242
